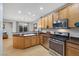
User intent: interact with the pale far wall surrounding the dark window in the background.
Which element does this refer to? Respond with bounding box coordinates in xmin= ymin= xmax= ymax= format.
xmin=4 ymin=19 xmax=33 ymax=33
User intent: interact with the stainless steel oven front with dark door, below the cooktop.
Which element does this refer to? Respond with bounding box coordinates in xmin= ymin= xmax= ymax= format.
xmin=49 ymin=38 xmax=65 ymax=55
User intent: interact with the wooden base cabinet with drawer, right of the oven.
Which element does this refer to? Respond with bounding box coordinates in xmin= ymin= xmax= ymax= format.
xmin=66 ymin=43 xmax=79 ymax=56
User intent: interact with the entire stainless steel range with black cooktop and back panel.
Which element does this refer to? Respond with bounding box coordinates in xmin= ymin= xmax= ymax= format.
xmin=49 ymin=32 xmax=69 ymax=56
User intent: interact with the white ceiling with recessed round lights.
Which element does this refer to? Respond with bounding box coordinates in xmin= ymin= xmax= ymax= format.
xmin=3 ymin=3 xmax=66 ymax=22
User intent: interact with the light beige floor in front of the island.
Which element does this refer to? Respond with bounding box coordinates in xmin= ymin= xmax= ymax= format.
xmin=3 ymin=39 xmax=51 ymax=56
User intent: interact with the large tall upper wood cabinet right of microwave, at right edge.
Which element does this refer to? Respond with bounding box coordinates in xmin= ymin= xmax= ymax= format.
xmin=68 ymin=4 xmax=79 ymax=27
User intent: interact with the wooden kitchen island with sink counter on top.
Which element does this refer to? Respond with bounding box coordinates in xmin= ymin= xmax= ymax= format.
xmin=13 ymin=33 xmax=40 ymax=49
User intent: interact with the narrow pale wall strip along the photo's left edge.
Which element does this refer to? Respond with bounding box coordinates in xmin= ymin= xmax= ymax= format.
xmin=0 ymin=3 xmax=3 ymax=55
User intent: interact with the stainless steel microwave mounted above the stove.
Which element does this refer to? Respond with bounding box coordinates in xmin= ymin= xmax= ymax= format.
xmin=53 ymin=19 xmax=68 ymax=29
